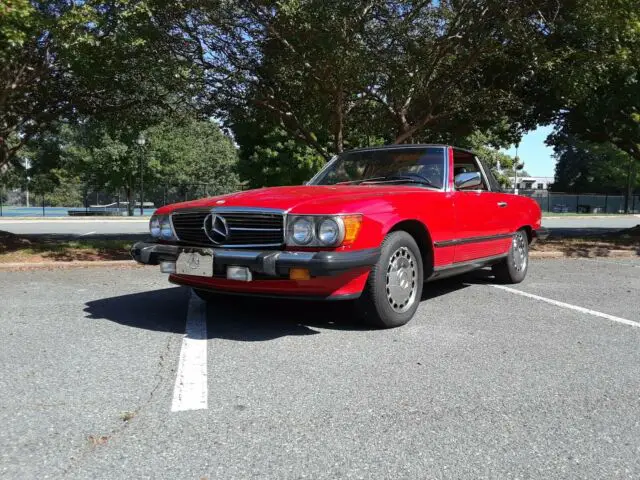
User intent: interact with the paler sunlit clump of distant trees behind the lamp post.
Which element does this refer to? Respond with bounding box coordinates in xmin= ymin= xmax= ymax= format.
xmin=60 ymin=118 xmax=239 ymax=214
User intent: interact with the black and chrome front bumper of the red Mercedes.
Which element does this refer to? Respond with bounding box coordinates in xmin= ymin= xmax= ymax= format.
xmin=131 ymin=242 xmax=380 ymax=278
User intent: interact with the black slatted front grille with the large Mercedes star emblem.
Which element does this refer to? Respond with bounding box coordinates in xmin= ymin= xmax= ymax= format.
xmin=171 ymin=210 xmax=284 ymax=247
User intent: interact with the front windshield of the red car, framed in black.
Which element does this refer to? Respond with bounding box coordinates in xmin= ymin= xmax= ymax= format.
xmin=310 ymin=147 xmax=446 ymax=189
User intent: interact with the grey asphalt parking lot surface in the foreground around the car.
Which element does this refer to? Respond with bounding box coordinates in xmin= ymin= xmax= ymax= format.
xmin=0 ymin=259 xmax=640 ymax=479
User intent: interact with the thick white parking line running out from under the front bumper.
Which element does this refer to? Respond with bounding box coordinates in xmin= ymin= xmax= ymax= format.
xmin=171 ymin=293 xmax=209 ymax=412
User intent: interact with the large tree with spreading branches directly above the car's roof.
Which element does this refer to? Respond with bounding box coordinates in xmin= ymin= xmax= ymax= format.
xmin=175 ymin=0 xmax=557 ymax=159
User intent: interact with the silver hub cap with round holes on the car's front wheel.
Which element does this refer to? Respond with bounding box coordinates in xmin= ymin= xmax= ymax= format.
xmin=386 ymin=247 xmax=418 ymax=313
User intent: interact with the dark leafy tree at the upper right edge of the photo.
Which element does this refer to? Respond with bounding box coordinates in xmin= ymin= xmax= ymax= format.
xmin=533 ymin=0 xmax=640 ymax=211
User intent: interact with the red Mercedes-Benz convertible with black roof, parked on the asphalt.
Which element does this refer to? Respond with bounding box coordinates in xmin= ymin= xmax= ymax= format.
xmin=131 ymin=145 xmax=545 ymax=327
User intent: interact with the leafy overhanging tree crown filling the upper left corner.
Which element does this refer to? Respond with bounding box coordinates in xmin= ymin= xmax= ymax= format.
xmin=0 ymin=0 xmax=199 ymax=169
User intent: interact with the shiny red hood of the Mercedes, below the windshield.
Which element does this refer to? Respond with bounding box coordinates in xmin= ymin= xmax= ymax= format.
xmin=158 ymin=185 xmax=437 ymax=214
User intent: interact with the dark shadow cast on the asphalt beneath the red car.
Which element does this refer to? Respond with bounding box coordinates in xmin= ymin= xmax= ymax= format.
xmin=84 ymin=275 xmax=482 ymax=342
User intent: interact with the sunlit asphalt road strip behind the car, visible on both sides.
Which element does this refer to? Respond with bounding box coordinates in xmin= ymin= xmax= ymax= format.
xmin=0 ymin=215 xmax=640 ymax=239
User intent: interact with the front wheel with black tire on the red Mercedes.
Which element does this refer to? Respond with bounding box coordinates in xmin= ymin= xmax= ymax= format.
xmin=356 ymin=231 xmax=424 ymax=328
